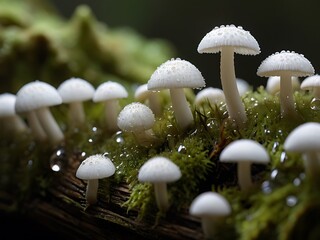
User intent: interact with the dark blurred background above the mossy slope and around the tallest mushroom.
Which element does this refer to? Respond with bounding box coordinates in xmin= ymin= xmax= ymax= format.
xmin=51 ymin=0 xmax=320 ymax=87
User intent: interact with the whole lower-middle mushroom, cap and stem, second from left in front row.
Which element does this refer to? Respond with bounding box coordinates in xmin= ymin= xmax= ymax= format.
xmin=138 ymin=156 xmax=181 ymax=212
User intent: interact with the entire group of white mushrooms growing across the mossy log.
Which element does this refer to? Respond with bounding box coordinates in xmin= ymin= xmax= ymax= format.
xmin=0 ymin=25 xmax=320 ymax=238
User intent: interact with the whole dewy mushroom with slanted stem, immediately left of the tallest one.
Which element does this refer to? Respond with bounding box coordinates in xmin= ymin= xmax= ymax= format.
xmin=148 ymin=58 xmax=205 ymax=130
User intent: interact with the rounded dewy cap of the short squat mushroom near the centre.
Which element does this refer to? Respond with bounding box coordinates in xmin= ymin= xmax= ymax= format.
xmin=117 ymin=102 xmax=155 ymax=132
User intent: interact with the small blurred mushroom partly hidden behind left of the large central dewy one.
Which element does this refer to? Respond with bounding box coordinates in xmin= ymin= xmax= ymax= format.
xmin=134 ymin=83 xmax=161 ymax=117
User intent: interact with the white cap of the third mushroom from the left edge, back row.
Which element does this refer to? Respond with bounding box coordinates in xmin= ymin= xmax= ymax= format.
xmin=57 ymin=78 xmax=95 ymax=103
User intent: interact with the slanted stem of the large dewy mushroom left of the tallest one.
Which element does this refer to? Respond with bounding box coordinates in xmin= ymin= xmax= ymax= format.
xmin=170 ymin=88 xmax=193 ymax=130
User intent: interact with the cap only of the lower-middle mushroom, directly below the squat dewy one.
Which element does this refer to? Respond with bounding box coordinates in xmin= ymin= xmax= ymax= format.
xmin=138 ymin=156 xmax=181 ymax=183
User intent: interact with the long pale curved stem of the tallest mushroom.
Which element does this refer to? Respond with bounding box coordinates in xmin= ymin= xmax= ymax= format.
xmin=220 ymin=47 xmax=247 ymax=128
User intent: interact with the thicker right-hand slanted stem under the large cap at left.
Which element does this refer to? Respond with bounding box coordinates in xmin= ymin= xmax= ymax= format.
xmin=36 ymin=107 xmax=64 ymax=144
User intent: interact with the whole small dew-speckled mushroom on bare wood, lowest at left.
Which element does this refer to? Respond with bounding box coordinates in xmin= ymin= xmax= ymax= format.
xmin=76 ymin=154 xmax=115 ymax=205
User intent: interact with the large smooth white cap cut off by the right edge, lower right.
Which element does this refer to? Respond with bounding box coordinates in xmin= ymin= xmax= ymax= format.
xmin=283 ymin=122 xmax=320 ymax=153
